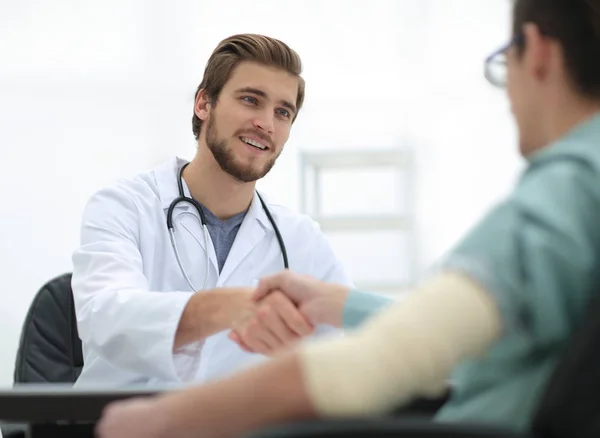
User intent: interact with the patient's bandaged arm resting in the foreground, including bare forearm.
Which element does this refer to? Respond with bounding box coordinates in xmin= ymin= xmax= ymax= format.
xmin=98 ymin=274 xmax=500 ymax=438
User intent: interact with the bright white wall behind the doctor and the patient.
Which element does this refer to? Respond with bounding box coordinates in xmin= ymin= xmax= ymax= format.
xmin=0 ymin=0 xmax=521 ymax=384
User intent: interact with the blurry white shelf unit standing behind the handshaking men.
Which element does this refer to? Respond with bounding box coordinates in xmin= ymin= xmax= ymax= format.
xmin=300 ymin=148 xmax=416 ymax=288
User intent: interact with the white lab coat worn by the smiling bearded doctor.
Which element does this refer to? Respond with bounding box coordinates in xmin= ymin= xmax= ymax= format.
xmin=72 ymin=158 xmax=351 ymax=386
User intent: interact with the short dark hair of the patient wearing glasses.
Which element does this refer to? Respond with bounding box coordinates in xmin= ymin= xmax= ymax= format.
xmin=513 ymin=0 xmax=600 ymax=99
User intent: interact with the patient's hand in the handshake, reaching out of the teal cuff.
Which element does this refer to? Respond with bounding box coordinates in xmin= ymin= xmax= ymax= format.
xmin=253 ymin=270 xmax=350 ymax=328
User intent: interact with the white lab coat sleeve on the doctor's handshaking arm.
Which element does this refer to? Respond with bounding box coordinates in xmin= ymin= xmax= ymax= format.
xmin=72 ymin=186 xmax=192 ymax=382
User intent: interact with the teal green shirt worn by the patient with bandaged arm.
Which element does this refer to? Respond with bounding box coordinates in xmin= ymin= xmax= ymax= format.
xmin=344 ymin=115 xmax=600 ymax=431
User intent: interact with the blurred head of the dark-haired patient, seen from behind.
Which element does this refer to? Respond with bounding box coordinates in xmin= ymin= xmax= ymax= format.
xmin=486 ymin=0 xmax=600 ymax=155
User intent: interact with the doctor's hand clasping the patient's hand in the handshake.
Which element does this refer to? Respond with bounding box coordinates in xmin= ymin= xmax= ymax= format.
xmin=229 ymin=292 xmax=314 ymax=355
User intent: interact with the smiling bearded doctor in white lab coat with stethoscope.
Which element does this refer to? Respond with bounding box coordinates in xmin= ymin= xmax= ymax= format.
xmin=72 ymin=34 xmax=350 ymax=386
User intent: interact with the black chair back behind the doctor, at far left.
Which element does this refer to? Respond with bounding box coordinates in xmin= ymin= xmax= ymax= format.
xmin=14 ymin=273 xmax=83 ymax=384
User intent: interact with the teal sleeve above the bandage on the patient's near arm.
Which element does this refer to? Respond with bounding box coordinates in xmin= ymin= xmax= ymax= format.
xmin=443 ymin=159 xmax=600 ymax=344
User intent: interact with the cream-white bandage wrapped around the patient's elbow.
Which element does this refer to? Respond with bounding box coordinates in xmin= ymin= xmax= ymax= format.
xmin=300 ymin=273 xmax=501 ymax=416
